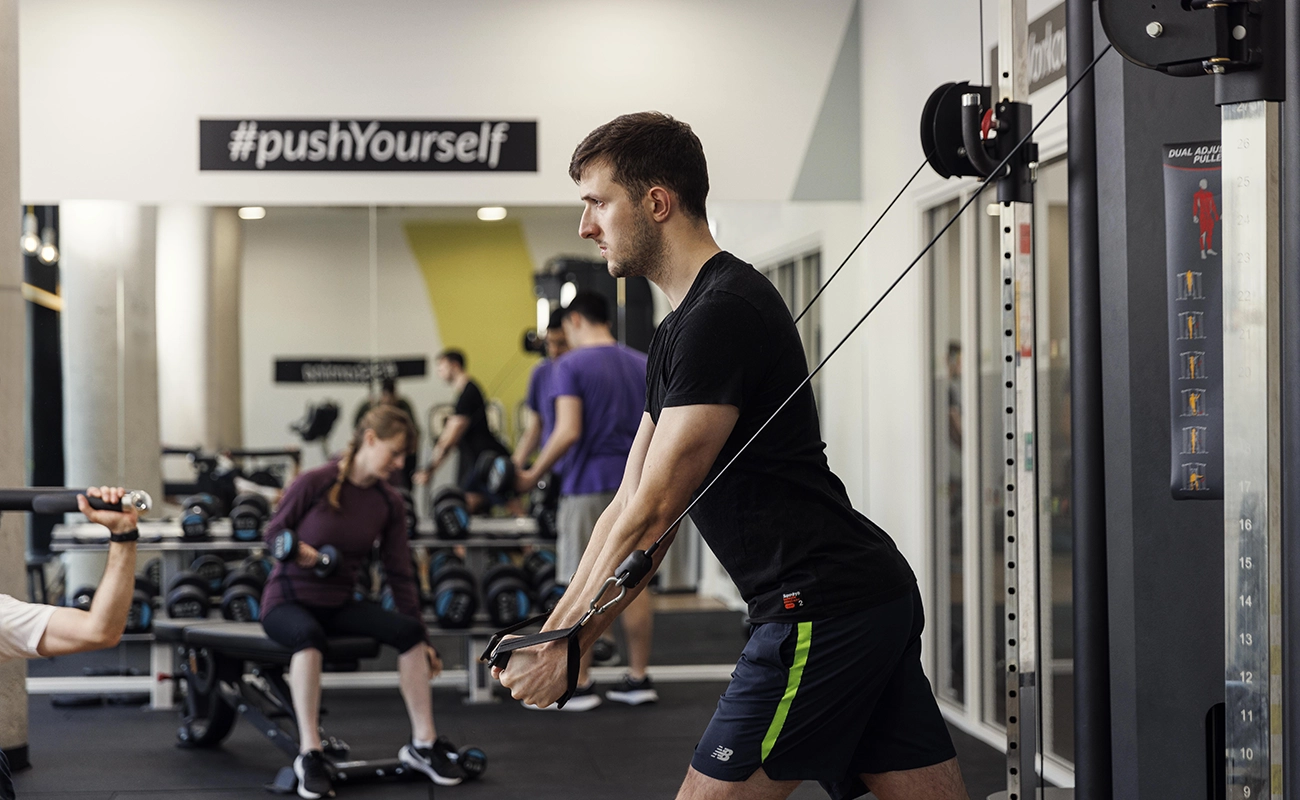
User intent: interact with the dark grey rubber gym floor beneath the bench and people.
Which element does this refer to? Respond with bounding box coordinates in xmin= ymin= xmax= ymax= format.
xmin=16 ymin=614 xmax=1005 ymax=800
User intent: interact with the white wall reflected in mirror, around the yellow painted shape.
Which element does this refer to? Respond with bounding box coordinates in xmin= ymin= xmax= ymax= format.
xmin=239 ymin=207 xmax=598 ymax=466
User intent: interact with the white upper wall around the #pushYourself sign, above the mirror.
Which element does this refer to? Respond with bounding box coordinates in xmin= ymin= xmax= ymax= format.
xmin=20 ymin=0 xmax=853 ymax=206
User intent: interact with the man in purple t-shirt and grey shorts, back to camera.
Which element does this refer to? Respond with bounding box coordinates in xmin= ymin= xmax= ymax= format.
xmin=519 ymin=291 xmax=659 ymax=712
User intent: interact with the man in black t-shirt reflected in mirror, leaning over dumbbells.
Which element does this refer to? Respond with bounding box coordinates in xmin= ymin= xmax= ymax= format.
xmin=416 ymin=350 xmax=510 ymax=513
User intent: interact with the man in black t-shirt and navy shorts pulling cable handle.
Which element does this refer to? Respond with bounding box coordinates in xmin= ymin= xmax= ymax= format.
xmin=494 ymin=113 xmax=969 ymax=800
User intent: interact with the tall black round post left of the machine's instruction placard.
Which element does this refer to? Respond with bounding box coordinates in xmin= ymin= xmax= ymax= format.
xmin=1066 ymin=0 xmax=1113 ymax=800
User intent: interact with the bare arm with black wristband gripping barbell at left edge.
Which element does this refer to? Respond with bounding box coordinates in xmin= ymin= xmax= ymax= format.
xmin=36 ymin=487 xmax=138 ymax=657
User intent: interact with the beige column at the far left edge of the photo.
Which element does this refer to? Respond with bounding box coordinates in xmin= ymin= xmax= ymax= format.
xmin=0 ymin=0 xmax=27 ymax=762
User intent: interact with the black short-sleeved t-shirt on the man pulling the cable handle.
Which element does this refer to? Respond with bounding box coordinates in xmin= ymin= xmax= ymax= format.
xmin=646 ymin=252 xmax=915 ymax=622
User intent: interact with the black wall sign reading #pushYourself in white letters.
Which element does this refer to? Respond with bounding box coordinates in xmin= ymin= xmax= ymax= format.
xmin=199 ymin=118 xmax=537 ymax=172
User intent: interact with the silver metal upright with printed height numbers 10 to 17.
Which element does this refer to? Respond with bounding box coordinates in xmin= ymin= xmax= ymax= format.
xmin=1222 ymin=101 xmax=1283 ymax=800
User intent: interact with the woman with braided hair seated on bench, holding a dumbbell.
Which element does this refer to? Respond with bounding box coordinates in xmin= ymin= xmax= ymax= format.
xmin=261 ymin=406 xmax=464 ymax=799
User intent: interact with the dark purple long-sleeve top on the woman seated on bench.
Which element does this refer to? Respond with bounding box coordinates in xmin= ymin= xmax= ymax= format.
xmin=261 ymin=460 xmax=424 ymax=634
